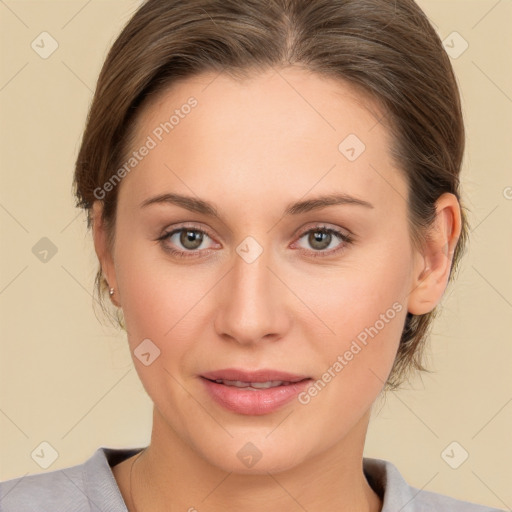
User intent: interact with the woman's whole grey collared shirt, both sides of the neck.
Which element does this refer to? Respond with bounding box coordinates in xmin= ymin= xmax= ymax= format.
xmin=0 ymin=447 xmax=499 ymax=512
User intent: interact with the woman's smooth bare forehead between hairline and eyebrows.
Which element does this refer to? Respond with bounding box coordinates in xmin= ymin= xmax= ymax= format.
xmin=118 ymin=68 xmax=404 ymax=214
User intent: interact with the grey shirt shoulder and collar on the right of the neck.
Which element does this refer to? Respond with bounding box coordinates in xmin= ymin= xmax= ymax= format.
xmin=363 ymin=457 xmax=506 ymax=512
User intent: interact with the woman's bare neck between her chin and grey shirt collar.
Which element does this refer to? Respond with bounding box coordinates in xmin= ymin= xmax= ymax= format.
xmin=130 ymin=408 xmax=381 ymax=512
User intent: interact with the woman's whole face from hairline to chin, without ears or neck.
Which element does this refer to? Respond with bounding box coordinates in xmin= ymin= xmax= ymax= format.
xmin=97 ymin=68 xmax=419 ymax=472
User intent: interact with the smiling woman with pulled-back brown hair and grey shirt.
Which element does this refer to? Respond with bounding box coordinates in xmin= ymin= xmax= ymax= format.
xmin=1 ymin=0 xmax=504 ymax=512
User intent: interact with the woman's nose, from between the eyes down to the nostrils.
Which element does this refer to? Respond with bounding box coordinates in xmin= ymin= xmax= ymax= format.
xmin=215 ymin=241 xmax=292 ymax=345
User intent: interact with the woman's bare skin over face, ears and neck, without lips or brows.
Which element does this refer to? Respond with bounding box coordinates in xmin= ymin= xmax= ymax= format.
xmin=93 ymin=67 xmax=460 ymax=512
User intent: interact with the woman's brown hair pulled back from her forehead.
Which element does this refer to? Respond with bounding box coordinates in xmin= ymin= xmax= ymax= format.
xmin=73 ymin=0 xmax=468 ymax=389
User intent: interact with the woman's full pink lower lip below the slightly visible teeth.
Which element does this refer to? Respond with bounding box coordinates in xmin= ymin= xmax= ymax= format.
xmin=201 ymin=377 xmax=311 ymax=415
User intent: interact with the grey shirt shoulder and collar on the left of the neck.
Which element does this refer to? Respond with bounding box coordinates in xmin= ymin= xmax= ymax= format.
xmin=0 ymin=447 xmax=142 ymax=512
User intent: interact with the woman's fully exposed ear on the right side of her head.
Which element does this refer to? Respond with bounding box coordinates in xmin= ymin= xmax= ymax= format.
xmin=408 ymin=193 xmax=461 ymax=315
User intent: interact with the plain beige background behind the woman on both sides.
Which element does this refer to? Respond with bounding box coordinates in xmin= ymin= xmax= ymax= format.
xmin=0 ymin=0 xmax=512 ymax=510
